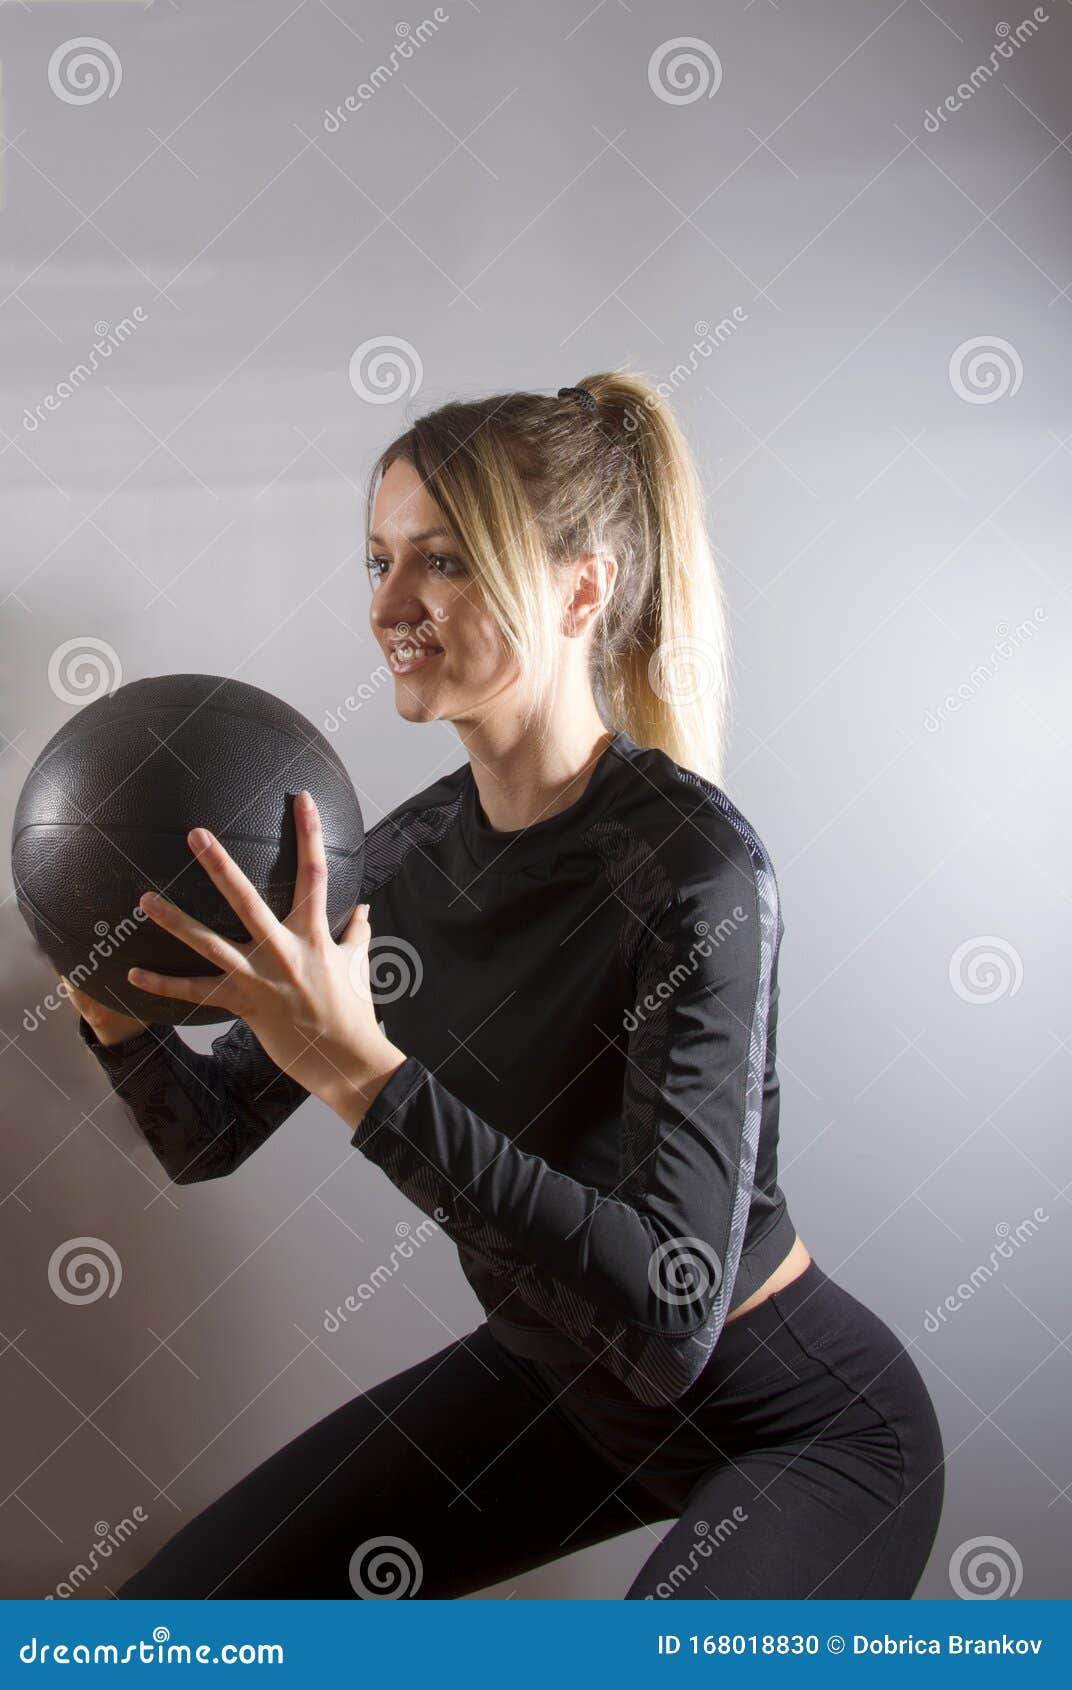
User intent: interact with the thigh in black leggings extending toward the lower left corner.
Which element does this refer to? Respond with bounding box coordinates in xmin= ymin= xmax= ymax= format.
xmin=118 ymin=1325 xmax=666 ymax=1600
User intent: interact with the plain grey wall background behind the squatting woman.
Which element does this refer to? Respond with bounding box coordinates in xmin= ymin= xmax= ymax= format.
xmin=0 ymin=0 xmax=1072 ymax=1597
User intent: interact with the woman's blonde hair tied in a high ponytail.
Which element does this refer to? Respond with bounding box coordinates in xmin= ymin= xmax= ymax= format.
xmin=369 ymin=370 xmax=729 ymax=782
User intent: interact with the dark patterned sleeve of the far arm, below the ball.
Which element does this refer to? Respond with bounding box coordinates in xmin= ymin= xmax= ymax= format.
xmin=78 ymin=1016 xmax=309 ymax=1185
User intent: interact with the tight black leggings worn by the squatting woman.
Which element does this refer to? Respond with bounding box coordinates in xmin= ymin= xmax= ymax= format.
xmin=118 ymin=1261 xmax=943 ymax=1600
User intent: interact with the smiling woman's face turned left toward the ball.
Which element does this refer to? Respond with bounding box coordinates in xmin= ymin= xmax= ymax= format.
xmin=369 ymin=458 xmax=517 ymax=723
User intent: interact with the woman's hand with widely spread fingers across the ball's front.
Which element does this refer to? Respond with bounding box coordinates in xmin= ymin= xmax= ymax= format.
xmin=127 ymin=791 xmax=406 ymax=1126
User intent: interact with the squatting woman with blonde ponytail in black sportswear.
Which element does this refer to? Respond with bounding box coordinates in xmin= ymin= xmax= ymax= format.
xmin=68 ymin=373 xmax=943 ymax=1599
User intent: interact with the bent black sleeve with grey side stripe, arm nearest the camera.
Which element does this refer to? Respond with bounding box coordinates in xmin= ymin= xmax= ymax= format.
xmin=352 ymin=833 xmax=781 ymax=1404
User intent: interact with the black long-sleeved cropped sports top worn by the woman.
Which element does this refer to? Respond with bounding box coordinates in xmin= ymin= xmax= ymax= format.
xmin=79 ymin=732 xmax=795 ymax=1404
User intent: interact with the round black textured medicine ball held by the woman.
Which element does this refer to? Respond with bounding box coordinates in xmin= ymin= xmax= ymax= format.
xmin=12 ymin=674 xmax=365 ymax=1026
